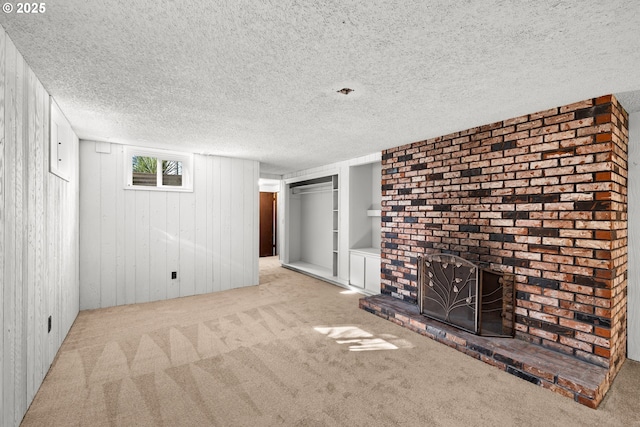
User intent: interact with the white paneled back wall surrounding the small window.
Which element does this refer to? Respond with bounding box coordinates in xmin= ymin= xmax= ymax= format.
xmin=80 ymin=141 xmax=260 ymax=309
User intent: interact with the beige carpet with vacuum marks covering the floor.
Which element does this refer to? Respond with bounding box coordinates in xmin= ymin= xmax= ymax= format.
xmin=18 ymin=258 xmax=640 ymax=426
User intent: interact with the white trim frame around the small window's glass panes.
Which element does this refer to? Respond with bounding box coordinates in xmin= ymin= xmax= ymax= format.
xmin=123 ymin=146 xmax=193 ymax=192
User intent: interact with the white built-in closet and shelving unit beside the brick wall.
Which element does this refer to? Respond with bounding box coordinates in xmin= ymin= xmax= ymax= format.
xmin=280 ymin=153 xmax=382 ymax=294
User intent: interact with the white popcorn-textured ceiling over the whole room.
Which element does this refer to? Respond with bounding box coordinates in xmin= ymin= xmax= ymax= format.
xmin=0 ymin=0 xmax=640 ymax=174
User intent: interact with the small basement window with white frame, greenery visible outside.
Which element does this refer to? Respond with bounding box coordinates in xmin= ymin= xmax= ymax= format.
xmin=124 ymin=147 xmax=193 ymax=191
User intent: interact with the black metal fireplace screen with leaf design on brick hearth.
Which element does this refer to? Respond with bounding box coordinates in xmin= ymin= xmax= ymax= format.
xmin=418 ymin=254 xmax=514 ymax=336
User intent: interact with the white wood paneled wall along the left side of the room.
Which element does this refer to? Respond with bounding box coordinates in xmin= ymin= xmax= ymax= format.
xmin=0 ymin=28 xmax=79 ymax=426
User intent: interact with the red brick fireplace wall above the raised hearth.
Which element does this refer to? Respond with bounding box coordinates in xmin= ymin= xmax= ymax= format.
xmin=382 ymin=96 xmax=628 ymax=374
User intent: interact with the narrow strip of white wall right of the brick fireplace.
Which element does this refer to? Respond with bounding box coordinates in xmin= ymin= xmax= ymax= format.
xmin=627 ymin=113 xmax=640 ymax=361
